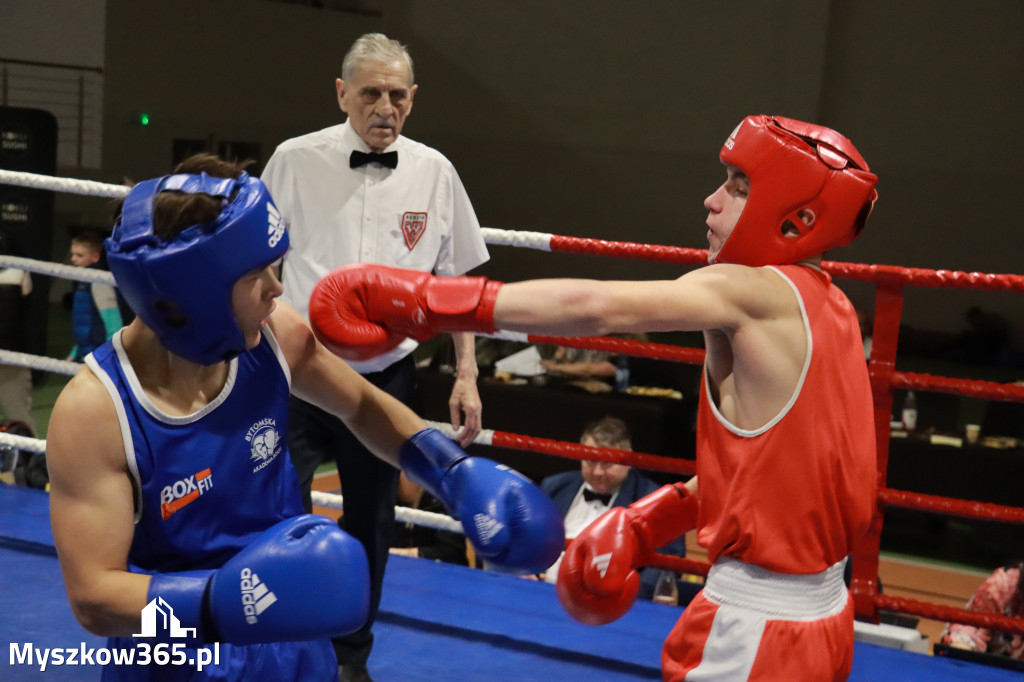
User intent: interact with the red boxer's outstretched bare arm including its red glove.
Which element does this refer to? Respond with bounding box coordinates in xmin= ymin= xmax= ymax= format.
xmin=309 ymin=258 xmax=800 ymax=348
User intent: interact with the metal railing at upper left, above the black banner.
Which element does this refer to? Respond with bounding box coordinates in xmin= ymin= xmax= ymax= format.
xmin=0 ymin=57 xmax=103 ymax=168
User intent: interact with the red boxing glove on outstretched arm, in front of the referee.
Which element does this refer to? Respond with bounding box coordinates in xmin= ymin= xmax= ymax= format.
xmin=309 ymin=263 xmax=502 ymax=360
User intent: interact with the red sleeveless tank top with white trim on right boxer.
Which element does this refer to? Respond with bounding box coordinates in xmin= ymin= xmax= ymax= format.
xmin=696 ymin=265 xmax=876 ymax=573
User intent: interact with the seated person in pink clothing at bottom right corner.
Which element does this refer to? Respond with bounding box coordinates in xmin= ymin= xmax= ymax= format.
xmin=939 ymin=561 xmax=1024 ymax=659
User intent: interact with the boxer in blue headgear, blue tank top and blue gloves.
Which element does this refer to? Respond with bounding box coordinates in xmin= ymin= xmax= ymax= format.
xmin=47 ymin=155 xmax=563 ymax=682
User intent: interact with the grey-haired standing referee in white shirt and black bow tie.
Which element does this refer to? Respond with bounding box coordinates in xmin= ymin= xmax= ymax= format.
xmin=262 ymin=33 xmax=488 ymax=680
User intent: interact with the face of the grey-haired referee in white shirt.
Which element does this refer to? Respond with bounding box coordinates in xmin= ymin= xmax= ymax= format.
xmin=335 ymin=60 xmax=417 ymax=152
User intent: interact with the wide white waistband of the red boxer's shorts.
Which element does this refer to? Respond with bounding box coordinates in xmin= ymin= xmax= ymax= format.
xmin=703 ymin=557 xmax=848 ymax=621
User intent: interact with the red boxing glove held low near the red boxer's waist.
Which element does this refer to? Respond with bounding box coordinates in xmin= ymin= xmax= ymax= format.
xmin=555 ymin=483 xmax=697 ymax=625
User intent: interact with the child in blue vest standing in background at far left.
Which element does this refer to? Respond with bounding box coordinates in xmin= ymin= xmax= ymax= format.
xmin=68 ymin=229 xmax=123 ymax=363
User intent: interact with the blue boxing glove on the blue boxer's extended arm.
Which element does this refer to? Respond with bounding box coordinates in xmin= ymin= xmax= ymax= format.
xmin=400 ymin=429 xmax=565 ymax=573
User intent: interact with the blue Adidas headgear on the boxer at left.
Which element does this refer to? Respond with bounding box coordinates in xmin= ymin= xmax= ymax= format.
xmin=105 ymin=173 xmax=288 ymax=365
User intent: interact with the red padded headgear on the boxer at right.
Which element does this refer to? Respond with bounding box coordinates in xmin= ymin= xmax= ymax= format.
xmin=715 ymin=116 xmax=879 ymax=265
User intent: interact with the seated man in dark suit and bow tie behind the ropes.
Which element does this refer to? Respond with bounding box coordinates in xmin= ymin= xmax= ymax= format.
xmin=541 ymin=417 xmax=686 ymax=599
